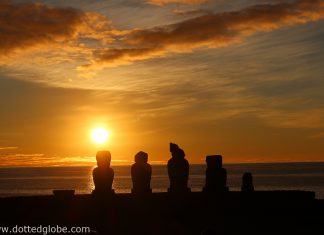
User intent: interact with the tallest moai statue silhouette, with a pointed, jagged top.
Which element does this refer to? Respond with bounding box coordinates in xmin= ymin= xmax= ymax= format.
xmin=168 ymin=143 xmax=190 ymax=193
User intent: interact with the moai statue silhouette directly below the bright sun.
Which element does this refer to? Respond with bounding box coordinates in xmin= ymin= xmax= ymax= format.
xmin=92 ymin=151 xmax=114 ymax=195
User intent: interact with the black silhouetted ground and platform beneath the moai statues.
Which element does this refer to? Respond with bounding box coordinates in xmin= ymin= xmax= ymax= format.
xmin=0 ymin=191 xmax=324 ymax=235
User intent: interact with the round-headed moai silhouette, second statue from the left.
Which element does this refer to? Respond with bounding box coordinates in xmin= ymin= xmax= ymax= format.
xmin=131 ymin=151 xmax=152 ymax=195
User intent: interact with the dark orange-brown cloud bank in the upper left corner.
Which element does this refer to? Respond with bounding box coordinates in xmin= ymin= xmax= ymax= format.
xmin=0 ymin=1 xmax=118 ymax=56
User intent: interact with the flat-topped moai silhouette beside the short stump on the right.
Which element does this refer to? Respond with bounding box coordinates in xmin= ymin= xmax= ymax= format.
xmin=203 ymin=155 xmax=228 ymax=192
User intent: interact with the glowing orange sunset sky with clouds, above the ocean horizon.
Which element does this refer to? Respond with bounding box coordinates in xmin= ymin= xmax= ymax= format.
xmin=0 ymin=0 xmax=324 ymax=166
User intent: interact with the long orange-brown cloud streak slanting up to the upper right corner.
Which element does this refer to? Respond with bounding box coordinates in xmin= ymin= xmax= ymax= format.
xmin=83 ymin=0 xmax=324 ymax=68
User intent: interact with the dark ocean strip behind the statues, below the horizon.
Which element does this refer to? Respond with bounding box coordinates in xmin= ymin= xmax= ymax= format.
xmin=0 ymin=162 xmax=324 ymax=199
